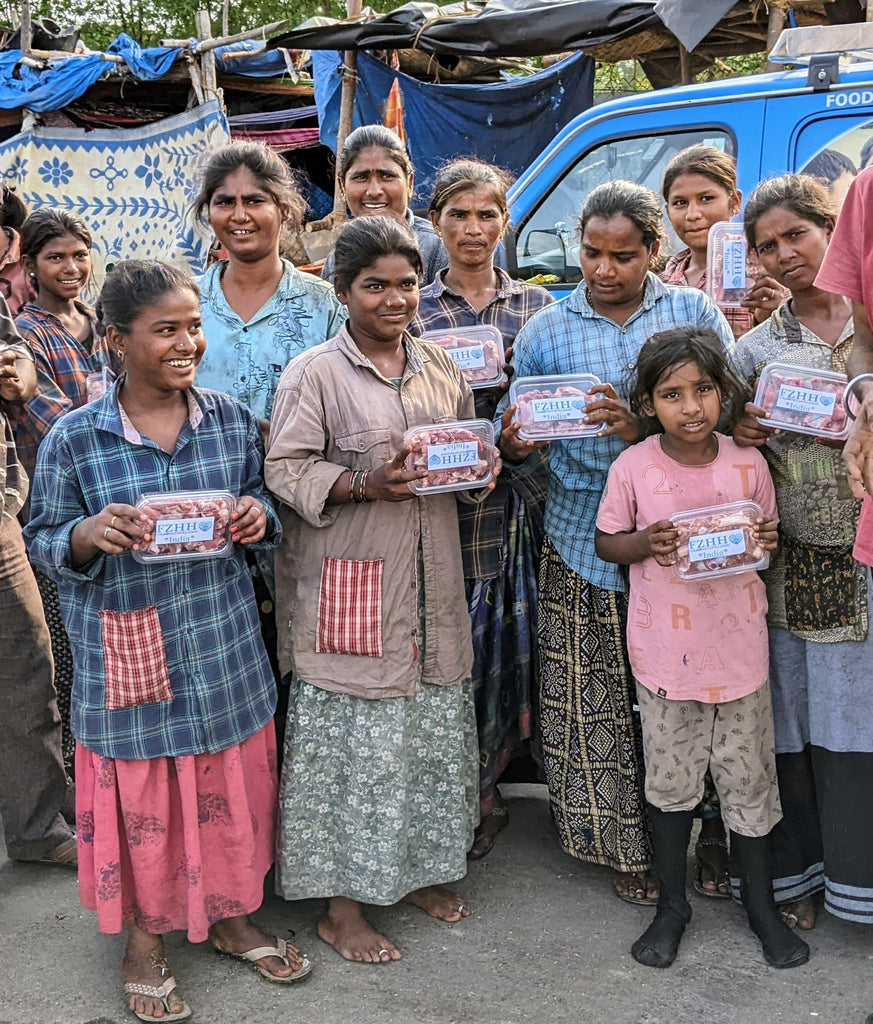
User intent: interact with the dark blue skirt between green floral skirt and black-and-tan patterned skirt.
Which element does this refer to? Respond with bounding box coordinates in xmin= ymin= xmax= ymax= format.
xmin=467 ymin=494 xmax=539 ymax=818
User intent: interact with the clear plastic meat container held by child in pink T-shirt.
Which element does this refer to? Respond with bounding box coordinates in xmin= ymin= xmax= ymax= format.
xmin=670 ymin=502 xmax=770 ymax=582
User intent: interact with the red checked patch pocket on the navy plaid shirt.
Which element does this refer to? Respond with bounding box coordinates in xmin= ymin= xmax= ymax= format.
xmin=100 ymin=605 xmax=173 ymax=711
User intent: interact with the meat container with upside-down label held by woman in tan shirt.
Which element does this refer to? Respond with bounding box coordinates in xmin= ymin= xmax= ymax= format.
xmin=403 ymin=420 xmax=494 ymax=495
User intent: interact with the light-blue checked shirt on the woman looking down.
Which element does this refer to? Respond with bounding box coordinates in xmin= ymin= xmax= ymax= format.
xmin=498 ymin=273 xmax=734 ymax=593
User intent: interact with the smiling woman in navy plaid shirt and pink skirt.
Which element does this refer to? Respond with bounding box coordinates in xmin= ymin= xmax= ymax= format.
xmin=26 ymin=261 xmax=310 ymax=1021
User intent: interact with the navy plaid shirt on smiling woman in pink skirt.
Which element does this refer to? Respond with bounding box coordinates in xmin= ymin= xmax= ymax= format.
xmin=25 ymin=385 xmax=281 ymax=759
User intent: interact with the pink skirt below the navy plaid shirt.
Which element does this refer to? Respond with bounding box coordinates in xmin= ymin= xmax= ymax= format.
xmin=76 ymin=722 xmax=278 ymax=942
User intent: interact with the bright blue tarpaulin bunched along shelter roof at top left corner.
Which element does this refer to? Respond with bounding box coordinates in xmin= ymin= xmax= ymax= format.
xmin=0 ymin=33 xmax=288 ymax=113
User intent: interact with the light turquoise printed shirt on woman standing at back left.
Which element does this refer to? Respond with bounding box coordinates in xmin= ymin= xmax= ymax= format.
xmin=197 ymin=260 xmax=346 ymax=420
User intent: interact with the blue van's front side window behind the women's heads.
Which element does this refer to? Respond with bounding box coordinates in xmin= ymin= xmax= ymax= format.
xmin=516 ymin=128 xmax=736 ymax=284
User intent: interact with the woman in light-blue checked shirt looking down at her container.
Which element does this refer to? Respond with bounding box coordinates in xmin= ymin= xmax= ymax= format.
xmin=493 ymin=181 xmax=733 ymax=904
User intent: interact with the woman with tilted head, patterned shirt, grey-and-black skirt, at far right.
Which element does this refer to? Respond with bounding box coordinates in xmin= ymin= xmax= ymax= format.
xmin=733 ymin=174 xmax=873 ymax=930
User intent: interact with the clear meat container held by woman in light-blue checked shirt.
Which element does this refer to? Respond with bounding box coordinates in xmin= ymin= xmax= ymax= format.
xmin=510 ymin=374 xmax=606 ymax=441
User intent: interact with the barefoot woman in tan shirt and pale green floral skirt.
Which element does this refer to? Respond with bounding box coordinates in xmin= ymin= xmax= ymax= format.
xmin=266 ymin=217 xmax=499 ymax=964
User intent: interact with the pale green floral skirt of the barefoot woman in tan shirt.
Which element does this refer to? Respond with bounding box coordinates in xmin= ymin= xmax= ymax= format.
xmin=276 ymin=680 xmax=479 ymax=906
